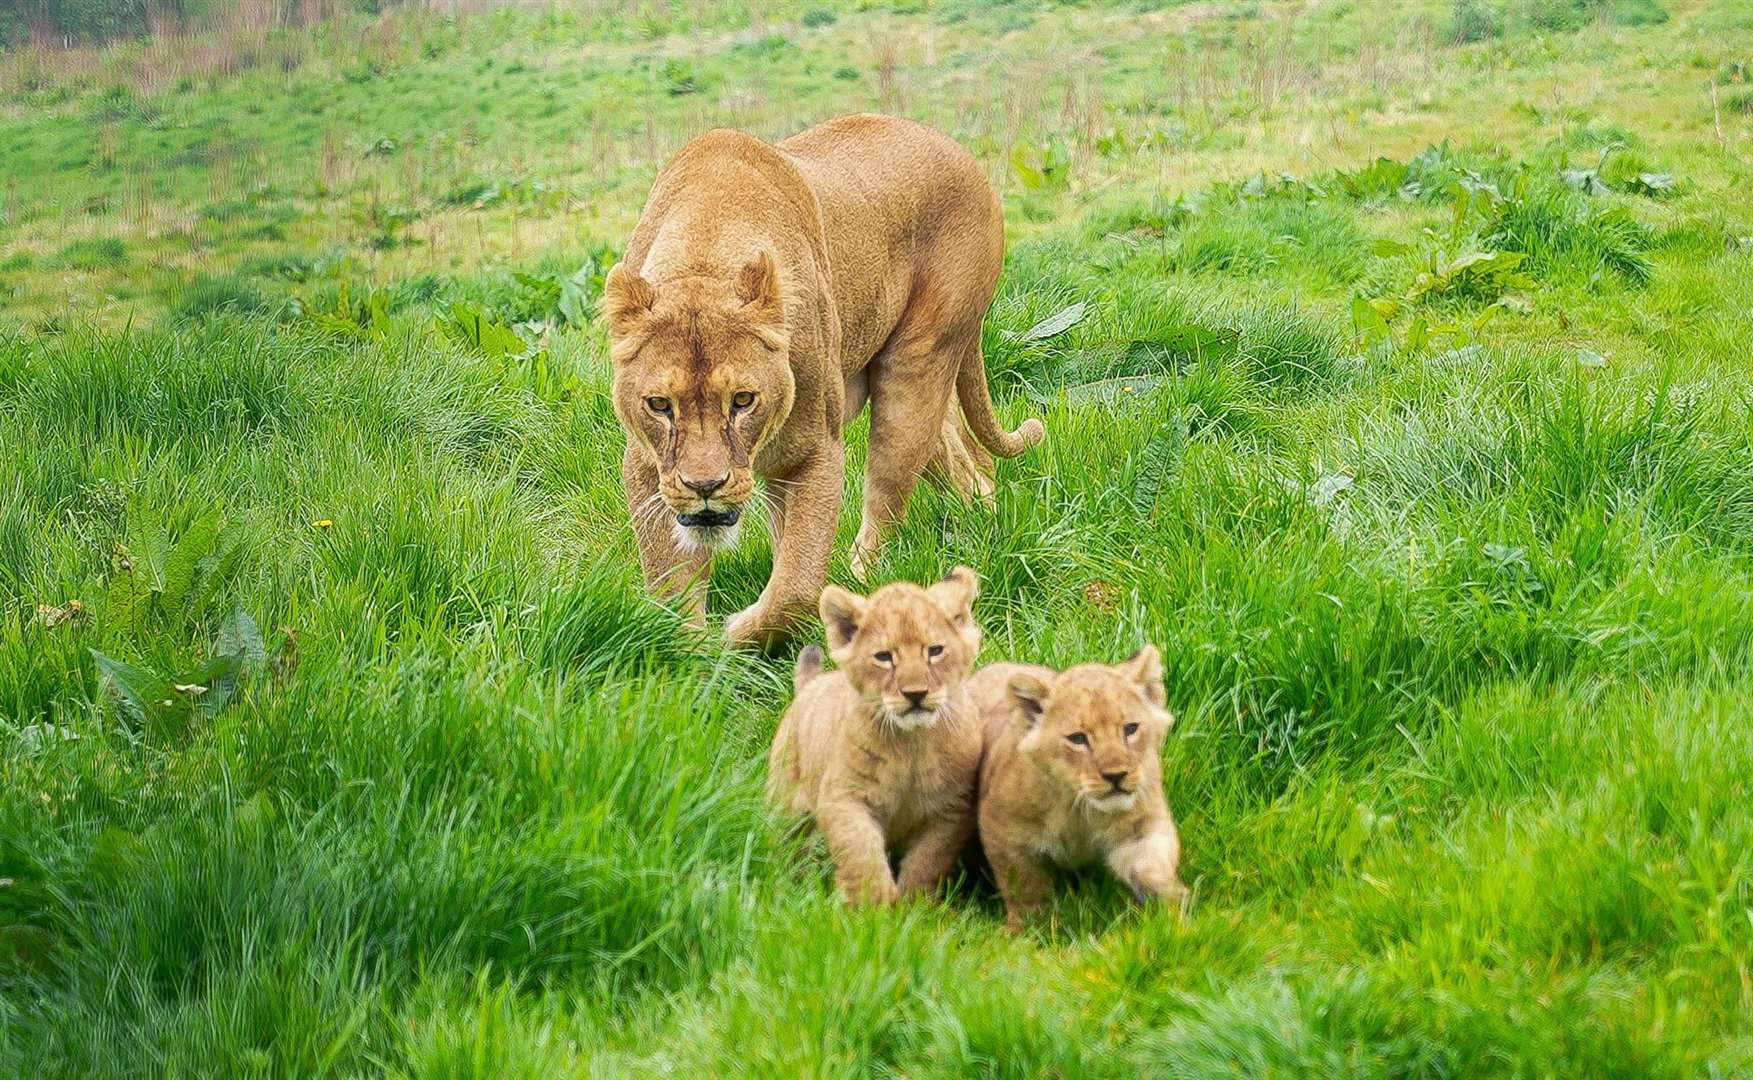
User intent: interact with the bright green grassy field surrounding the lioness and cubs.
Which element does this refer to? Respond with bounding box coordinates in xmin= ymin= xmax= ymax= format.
xmin=0 ymin=0 xmax=1753 ymax=1080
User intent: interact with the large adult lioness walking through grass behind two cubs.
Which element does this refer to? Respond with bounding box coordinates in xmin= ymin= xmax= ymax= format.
xmin=603 ymin=116 xmax=1043 ymax=643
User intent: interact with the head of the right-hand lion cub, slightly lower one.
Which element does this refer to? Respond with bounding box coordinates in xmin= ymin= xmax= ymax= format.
xmin=1008 ymin=645 xmax=1175 ymax=812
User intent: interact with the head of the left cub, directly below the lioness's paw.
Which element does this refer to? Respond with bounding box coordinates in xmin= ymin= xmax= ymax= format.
xmin=820 ymin=566 xmax=980 ymax=731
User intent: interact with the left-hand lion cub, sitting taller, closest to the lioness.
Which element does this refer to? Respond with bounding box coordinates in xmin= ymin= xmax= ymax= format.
xmin=768 ymin=566 xmax=980 ymax=903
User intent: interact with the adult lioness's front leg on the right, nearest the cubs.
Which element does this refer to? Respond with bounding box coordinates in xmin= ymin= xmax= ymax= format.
xmin=724 ymin=442 xmax=845 ymax=647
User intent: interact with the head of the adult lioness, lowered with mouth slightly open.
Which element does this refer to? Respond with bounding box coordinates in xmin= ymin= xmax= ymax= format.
xmin=603 ymin=252 xmax=796 ymax=547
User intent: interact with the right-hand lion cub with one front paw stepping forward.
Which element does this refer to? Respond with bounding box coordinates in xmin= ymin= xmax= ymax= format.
xmin=968 ymin=645 xmax=1187 ymax=931
